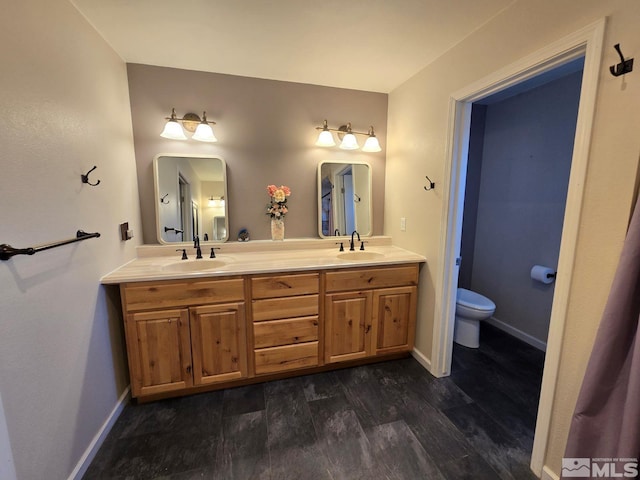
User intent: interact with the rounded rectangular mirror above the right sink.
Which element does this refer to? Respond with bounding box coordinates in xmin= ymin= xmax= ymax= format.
xmin=318 ymin=162 xmax=372 ymax=238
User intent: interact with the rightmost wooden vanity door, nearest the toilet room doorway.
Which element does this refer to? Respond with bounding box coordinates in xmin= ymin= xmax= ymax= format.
xmin=373 ymin=287 xmax=417 ymax=354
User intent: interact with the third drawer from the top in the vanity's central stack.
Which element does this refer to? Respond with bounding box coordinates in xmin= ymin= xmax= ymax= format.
xmin=253 ymin=316 xmax=318 ymax=348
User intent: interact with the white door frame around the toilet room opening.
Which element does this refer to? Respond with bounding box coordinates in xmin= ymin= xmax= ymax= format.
xmin=431 ymin=18 xmax=606 ymax=476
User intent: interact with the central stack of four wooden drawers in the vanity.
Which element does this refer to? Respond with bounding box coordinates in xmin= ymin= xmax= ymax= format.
xmin=251 ymin=273 xmax=320 ymax=375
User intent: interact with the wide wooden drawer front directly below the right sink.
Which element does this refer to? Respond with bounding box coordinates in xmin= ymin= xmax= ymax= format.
xmin=325 ymin=265 xmax=418 ymax=292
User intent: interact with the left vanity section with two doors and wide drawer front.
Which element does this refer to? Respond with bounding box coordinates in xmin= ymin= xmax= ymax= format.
xmin=120 ymin=278 xmax=247 ymax=397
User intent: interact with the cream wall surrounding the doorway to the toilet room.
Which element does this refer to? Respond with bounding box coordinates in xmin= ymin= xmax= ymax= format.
xmin=384 ymin=0 xmax=640 ymax=472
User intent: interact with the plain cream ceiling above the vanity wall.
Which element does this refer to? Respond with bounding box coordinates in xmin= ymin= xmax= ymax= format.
xmin=71 ymin=0 xmax=514 ymax=93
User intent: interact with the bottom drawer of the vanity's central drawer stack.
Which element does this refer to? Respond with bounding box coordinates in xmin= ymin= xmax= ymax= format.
xmin=255 ymin=342 xmax=318 ymax=375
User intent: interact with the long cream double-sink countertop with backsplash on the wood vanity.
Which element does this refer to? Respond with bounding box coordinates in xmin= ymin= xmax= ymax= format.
xmin=100 ymin=237 xmax=426 ymax=284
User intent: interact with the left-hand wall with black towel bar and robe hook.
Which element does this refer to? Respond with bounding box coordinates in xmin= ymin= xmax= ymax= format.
xmin=0 ymin=0 xmax=142 ymax=480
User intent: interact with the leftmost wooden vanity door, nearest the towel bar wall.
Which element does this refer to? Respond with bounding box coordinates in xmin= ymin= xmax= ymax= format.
xmin=126 ymin=309 xmax=192 ymax=397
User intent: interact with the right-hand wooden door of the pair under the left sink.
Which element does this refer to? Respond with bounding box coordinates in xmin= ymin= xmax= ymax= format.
xmin=191 ymin=303 xmax=247 ymax=385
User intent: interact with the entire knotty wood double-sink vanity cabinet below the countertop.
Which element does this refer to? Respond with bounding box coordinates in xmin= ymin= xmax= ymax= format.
xmin=120 ymin=264 xmax=418 ymax=401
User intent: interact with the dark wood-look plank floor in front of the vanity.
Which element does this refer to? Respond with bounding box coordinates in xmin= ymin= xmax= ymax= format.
xmin=84 ymin=324 xmax=544 ymax=480
